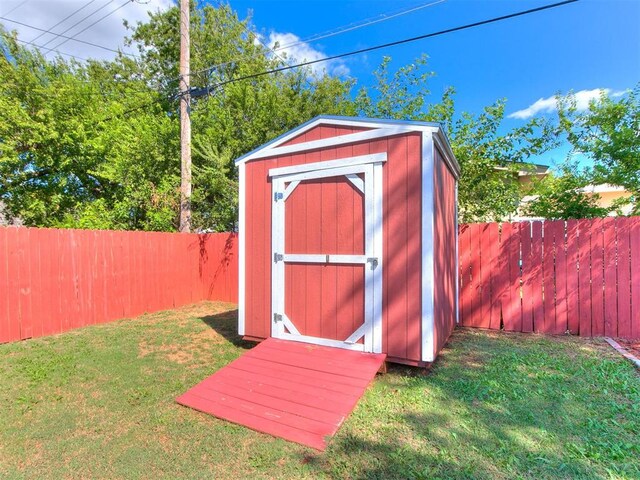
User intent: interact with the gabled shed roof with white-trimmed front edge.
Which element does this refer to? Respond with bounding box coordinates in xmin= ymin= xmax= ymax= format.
xmin=235 ymin=115 xmax=460 ymax=177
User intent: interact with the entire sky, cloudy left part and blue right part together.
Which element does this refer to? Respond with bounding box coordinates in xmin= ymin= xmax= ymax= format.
xmin=0 ymin=0 xmax=640 ymax=168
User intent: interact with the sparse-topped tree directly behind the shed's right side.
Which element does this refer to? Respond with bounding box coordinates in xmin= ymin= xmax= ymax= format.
xmin=355 ymin=55 xmax=554 ymax=222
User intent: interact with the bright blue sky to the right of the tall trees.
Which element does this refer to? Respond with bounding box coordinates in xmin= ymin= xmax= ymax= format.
xmin=230 ymin=0 xmax=640 ymax=164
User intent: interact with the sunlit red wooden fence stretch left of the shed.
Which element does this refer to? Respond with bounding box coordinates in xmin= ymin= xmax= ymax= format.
xmin=0 ymin=227 xmax=238 ymax=343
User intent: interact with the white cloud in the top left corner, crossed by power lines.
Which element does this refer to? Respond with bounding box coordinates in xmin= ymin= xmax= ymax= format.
xmin=0 ymin=0 xmax=174 ymax=60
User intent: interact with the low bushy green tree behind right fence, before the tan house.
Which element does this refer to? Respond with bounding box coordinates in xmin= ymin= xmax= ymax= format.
xmin=522 ymin=163 xmax=611 ymax=220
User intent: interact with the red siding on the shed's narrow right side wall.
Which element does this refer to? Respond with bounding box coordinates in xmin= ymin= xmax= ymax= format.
xmin=433 ymin=144 xmax=457 ymax=358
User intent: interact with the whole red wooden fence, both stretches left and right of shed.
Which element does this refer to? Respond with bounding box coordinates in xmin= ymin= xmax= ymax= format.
xmin=0 ymin=217 xmax=640 ymax=343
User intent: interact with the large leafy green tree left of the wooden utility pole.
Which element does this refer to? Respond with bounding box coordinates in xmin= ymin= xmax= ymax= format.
xmin=0 ymin=26 xmax=177 ymax=229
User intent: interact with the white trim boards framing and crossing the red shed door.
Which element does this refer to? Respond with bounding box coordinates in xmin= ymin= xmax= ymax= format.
xmin=269 ymin=154 xmax=386 ymax=353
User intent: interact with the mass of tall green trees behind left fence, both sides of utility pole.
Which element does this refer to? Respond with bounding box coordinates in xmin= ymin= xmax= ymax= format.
xmin=0 ymin=4 xmax=351 ymax=230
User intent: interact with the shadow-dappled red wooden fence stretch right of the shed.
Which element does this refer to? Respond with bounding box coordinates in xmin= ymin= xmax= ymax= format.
xmin=459 ymin=217 xmax=640 ymax=339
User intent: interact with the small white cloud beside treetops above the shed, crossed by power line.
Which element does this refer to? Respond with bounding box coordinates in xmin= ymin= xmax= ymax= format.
xmin=267 ymin=32 xmax=349 ymax=76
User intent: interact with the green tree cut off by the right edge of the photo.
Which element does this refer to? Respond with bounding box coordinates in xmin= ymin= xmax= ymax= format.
xmin=558 ymin=84 xmax=640 ymax=215
